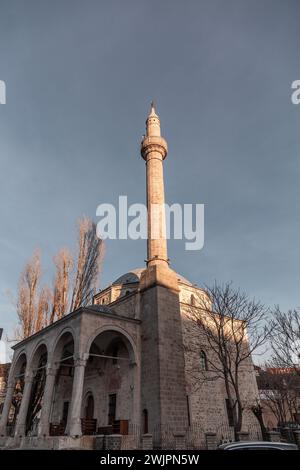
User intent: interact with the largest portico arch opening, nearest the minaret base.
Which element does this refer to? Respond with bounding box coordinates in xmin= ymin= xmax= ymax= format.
xmin=83 ymin=325 xmax=137 ymax=433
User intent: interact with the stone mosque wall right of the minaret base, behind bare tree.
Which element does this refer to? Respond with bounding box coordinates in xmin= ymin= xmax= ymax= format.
xmin=181 ymin=287 xmax=258 ymax=435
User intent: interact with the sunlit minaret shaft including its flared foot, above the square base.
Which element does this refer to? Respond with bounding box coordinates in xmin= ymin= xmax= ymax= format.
xmin=141 ymin=102 xmax=178 ymax=290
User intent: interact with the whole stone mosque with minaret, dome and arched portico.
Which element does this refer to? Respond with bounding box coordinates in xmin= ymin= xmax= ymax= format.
xmin=0 ymin=105 xmax=258 ymax=448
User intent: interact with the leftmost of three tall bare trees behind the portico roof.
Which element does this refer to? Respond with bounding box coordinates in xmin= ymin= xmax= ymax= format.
xmin=15 ymin=250 xmax=50 ymax=340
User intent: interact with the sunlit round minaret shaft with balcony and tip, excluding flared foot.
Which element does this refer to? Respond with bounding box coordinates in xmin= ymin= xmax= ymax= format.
xmin=141 ymin=101 xmax=168 ymax=266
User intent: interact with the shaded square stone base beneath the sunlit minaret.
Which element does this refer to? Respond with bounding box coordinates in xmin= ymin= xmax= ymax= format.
xmin=141 ymin=280 xmax=187 ymax=432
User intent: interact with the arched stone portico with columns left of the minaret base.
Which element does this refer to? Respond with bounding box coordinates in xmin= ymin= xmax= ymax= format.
xmin=0 ymin=323 xmax=140 ymax=438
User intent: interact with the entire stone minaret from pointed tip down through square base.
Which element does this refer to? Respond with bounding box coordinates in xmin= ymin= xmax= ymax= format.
xmin=140 ymin=103 xmax=188 ymax=438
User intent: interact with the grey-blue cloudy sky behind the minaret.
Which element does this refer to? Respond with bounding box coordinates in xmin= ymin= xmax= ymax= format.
xmin=0 ymin=0 xmax=300 ymax=348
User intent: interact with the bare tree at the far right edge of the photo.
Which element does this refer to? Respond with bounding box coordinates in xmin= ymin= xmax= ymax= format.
xmin=271 ymin=306 xmax=300 ymax=375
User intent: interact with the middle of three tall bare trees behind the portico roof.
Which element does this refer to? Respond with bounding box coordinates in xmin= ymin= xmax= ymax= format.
xmin=49 ymin=248 xmax=73 ymax=323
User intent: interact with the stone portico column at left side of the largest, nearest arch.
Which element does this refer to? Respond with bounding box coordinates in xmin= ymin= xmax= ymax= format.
xmin=67 ymin=355 xmax=88 ymax=437
